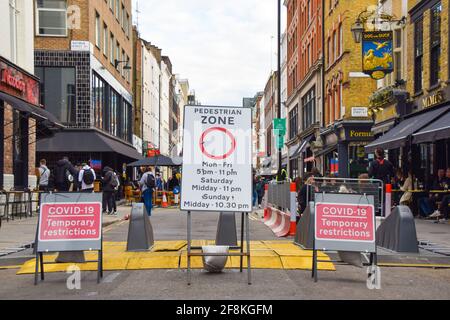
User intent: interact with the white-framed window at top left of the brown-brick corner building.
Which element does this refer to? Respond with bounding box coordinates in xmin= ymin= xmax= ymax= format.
xmin=36 ymin=0 xmax=67 ymax=36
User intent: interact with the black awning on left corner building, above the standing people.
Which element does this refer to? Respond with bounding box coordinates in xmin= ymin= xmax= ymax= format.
xmin=37 ymin=130 xmax=142 ymax=160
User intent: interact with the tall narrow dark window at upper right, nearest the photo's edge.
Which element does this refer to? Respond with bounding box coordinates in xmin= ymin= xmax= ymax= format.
xmin=430 ymin=2 xmax=442 ymax=86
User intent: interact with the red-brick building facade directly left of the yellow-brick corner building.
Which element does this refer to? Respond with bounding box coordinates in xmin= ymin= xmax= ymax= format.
xmin=285 ymin=0 xmax=323 ymax=178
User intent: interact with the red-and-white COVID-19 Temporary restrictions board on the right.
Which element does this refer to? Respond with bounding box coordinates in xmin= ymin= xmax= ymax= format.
xmin=314 ymin=193 xmax=376 ymax=252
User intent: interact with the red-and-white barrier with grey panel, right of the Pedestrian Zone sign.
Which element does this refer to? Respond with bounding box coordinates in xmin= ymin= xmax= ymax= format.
xmin=264 ymin=182 xmax=297 ymax=238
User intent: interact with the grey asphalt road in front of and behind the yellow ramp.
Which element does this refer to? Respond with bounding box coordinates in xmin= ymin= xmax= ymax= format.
xmin=0 ymin=210 xmax=450 ymax=300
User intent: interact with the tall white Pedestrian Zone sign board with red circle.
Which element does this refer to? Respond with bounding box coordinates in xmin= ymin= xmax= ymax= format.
xmin=181 ymin=106 xmax=252 ymax=212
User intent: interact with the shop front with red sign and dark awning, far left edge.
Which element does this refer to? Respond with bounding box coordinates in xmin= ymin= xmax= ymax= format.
xmin=0 ymin=57 xmax=62 ymax=190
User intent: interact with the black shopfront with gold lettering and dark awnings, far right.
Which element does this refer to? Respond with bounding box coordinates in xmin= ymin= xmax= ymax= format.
xmin=366 ymin=88 xmax=450 ymax=187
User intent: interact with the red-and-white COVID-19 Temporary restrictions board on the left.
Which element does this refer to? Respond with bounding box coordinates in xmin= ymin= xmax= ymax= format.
xmin=37 ymin=193 xmax=102 ymax=252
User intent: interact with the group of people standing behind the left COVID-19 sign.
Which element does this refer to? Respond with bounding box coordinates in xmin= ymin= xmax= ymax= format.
xmin=38 ymin=157 xmax=121 ymax=215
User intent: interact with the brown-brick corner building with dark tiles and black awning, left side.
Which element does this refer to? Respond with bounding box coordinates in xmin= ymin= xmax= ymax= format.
xmin=35 ymin=0 xmax=140 ymax=172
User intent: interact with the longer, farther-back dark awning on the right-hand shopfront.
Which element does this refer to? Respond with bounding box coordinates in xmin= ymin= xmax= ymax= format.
xmin=366 ymin=106 xmax=450 ymax=152
